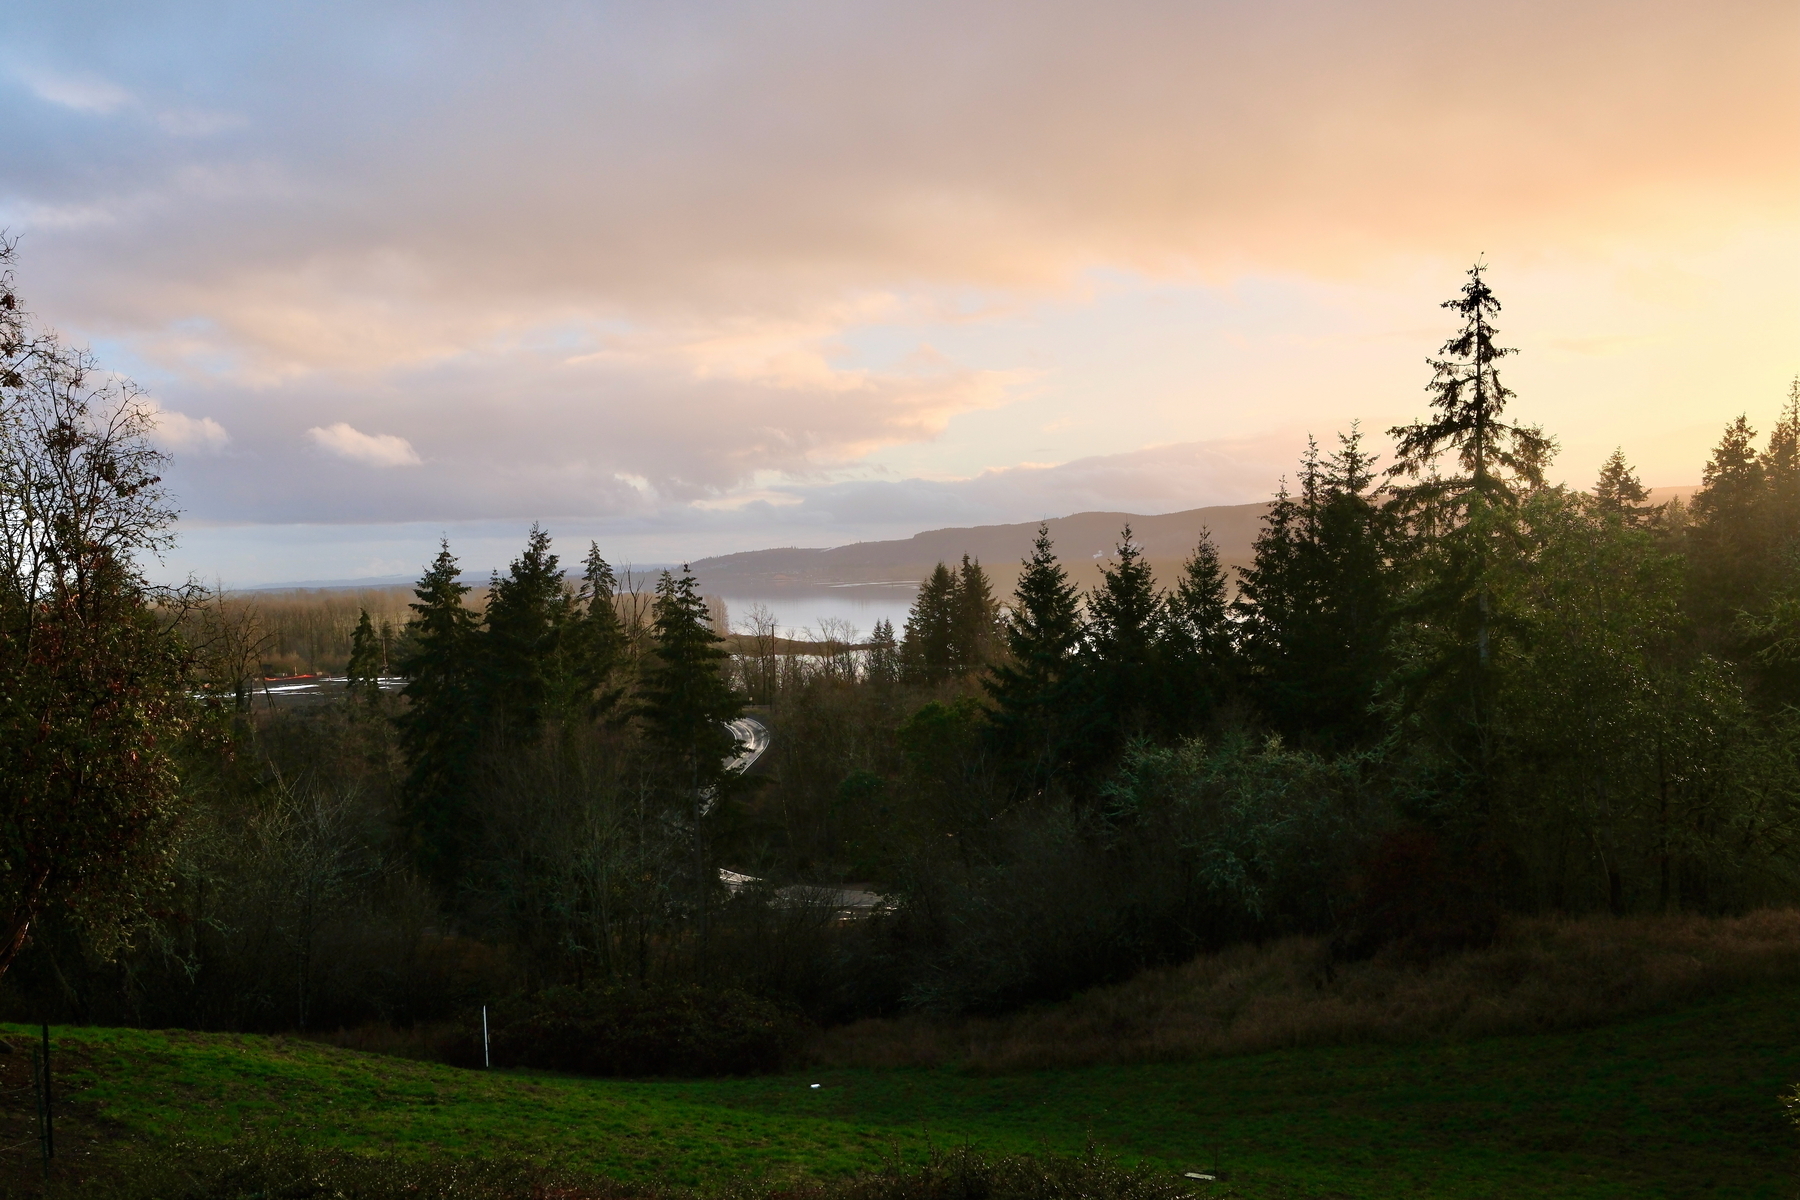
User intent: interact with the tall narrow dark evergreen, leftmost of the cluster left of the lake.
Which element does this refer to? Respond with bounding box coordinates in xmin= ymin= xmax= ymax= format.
xmin=396 ymin=542 xmax=481 ymax=885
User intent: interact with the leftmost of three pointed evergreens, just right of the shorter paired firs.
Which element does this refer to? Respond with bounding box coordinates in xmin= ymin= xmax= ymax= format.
xmin=983 ymin=525 xmax=1084 ymax=792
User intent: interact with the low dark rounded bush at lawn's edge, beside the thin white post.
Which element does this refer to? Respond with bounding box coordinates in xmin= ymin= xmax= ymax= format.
xmin=454 ymin=988 xmax=799 ymax=1076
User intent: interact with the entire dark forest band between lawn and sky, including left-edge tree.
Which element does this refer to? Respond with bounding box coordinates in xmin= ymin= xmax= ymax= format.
xmin=0 ymin=251 xmax=1800 ymax=1074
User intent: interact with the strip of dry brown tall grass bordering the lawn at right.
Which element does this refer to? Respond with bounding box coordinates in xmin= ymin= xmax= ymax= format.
xmin=806 ymin=909 xmax=1800 ymax=1072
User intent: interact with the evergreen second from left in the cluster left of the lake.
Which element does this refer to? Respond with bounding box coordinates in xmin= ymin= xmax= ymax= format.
xmin=481 ymin=525 xmax=572 ymax=741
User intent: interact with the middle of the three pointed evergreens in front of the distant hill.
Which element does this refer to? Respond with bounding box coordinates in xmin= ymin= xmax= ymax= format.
xmin=1085 ymin=525 xmax=1165 ymax=747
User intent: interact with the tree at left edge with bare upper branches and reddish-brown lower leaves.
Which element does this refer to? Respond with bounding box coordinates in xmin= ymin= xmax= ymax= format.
xmin=0 ymin=239 xmax=196 ymax=973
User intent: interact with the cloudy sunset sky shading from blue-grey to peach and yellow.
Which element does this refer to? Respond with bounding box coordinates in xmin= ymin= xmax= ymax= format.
xmin=0 ymin=0 xmax=1800 ymax=587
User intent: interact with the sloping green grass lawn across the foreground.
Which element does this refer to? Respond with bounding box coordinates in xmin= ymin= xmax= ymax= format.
xmin=13 ymin=991 xmax=1800 ymax=1200
